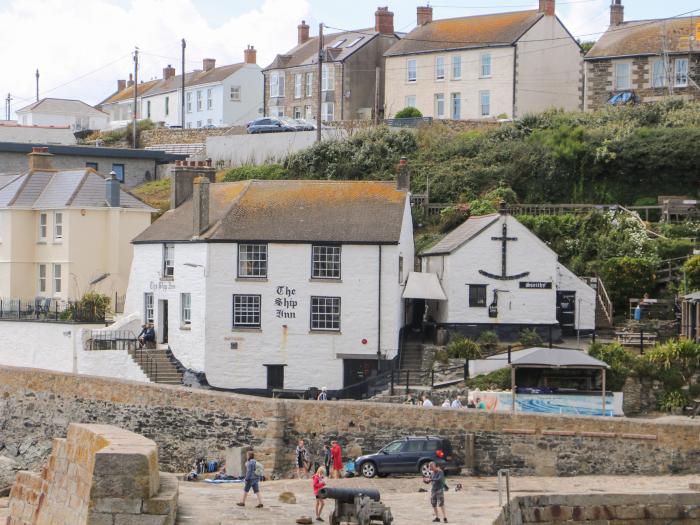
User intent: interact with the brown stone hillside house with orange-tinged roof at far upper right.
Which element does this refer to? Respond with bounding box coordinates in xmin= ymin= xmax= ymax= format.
xmin=585 ymin=0 xmax=700 ymax=111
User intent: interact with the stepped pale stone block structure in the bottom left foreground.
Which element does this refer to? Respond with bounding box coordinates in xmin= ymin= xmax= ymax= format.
xmin=7 ymin=424 xmax=177 ymax=525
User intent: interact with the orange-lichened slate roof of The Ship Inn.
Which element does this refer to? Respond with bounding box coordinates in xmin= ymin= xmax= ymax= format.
xmin=133 ymin=180 xmax=406 ymax=244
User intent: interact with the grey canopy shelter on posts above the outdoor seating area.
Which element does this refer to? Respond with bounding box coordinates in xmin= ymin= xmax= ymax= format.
xmin=510 ymin=348 xmax=610 ymax=415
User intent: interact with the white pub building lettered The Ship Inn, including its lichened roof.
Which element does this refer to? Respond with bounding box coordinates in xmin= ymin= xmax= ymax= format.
xmin=125 ymin=168 xmax=414 ymax=392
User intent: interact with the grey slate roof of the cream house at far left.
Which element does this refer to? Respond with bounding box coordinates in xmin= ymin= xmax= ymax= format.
xmin=0 ymin=168 xmax=155 ymax=212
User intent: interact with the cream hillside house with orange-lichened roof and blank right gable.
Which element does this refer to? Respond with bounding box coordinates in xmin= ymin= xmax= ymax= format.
xmin=384 ymin=0 xmax=583 ymax=120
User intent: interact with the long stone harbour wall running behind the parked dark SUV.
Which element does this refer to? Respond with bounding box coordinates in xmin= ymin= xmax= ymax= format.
xmin=0 ymin=367 xmax=700 ymax=484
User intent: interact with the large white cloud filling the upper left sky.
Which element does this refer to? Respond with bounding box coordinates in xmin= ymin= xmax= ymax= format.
xmin=0 ymin=0 xmax=310 ymax=111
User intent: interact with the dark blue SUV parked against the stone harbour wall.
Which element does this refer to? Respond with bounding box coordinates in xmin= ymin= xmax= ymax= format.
xmin=355 ymin=436 xmax=464 ymax=478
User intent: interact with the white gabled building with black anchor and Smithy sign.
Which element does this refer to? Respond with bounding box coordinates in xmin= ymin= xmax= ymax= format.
xmin=418 ymin=208 xmax=596 ymax=340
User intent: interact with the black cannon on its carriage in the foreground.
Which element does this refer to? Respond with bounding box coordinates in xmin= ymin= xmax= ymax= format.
xmin=318 ymin=488 xmax=394 ymax=525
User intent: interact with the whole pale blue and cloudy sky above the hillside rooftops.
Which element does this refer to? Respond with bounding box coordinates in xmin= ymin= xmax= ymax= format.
xmin=0 ymin=0 xmax=700 ymax=118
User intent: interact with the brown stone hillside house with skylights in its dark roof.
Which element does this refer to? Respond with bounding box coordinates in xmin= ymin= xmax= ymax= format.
xmin=263 ymin=7 xmax=399 ymax=122
